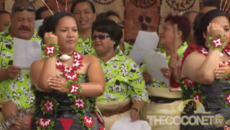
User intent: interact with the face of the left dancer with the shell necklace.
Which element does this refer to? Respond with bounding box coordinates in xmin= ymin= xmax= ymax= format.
xmin=55 ymin=16 xmax=78 ymax=52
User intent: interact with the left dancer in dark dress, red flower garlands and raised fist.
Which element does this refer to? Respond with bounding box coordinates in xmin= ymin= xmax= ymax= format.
xmin=30 ymin=12 xmax=105 ymax=130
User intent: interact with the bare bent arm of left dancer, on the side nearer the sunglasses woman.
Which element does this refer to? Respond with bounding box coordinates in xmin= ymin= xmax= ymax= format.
xmin=80 ymin=55 xmax=105 ymax=97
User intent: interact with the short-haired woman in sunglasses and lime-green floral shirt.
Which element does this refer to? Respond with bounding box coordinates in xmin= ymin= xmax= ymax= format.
xmin=92 ymin=19 xmax=148 ymax=130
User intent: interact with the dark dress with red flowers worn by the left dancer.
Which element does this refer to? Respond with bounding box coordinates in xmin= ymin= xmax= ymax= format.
xmin=31 ymin=74 xmax=104 ymax=130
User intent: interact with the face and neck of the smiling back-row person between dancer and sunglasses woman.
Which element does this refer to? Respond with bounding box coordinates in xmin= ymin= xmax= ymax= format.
xmin=73 ymin=2 xmax=96 ymax=40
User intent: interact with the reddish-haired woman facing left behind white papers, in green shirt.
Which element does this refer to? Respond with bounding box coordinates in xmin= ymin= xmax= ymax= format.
xmin=140 ymin=15 xmax=191 ymax=88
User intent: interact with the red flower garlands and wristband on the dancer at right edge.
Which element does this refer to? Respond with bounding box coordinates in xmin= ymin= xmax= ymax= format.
xmin=179 ymin=46 xmax=230 ymax=107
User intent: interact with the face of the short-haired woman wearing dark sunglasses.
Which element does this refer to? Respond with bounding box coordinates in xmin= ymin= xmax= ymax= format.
xmin=92 ymin=30 xmax=115 ymax=54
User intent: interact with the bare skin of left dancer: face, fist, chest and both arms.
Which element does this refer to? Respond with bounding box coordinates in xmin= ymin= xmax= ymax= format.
xmin=30 ymin=17 xmax=105 ymax=97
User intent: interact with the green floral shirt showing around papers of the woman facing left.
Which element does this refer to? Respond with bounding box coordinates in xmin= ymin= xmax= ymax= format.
xmin=140 ymin=42 xmax=188 ymax=88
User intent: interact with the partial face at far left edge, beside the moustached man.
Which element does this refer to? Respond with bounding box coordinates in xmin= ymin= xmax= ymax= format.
xmin=0 ymin=13 xmax=10 ymax=32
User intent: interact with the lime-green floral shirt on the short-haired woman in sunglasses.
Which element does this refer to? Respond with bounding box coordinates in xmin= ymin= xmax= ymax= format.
xmin=97 ymin=51 xmax=148 ymax=102
